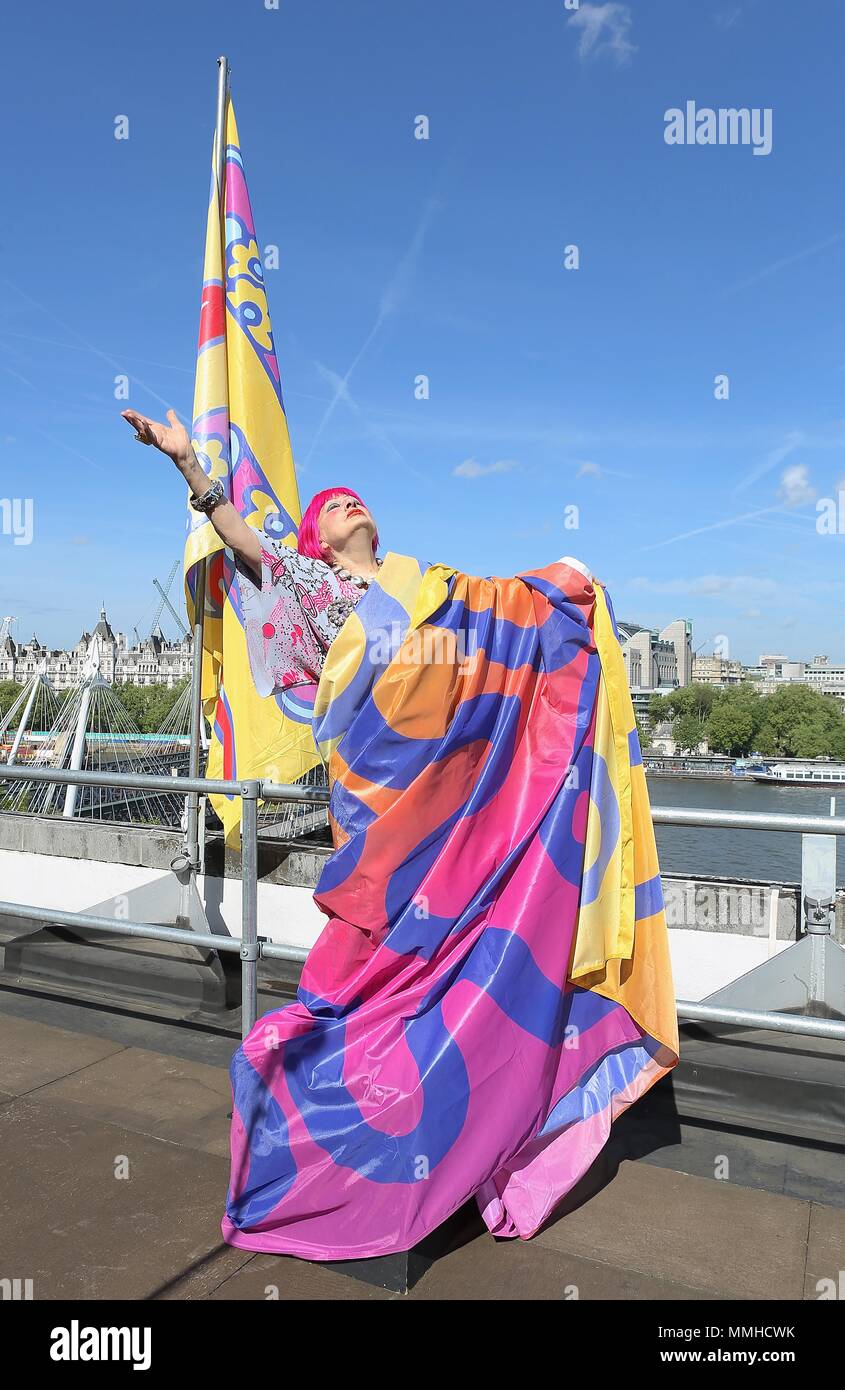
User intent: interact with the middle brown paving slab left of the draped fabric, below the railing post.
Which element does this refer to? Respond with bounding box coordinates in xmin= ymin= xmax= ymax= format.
xmin=31 ymin=1047 xmax=232 ymax=1158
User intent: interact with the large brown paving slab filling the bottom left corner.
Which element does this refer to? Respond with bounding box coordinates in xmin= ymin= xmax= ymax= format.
xmin=0 ymin=1098 xmax=236 ymax=1300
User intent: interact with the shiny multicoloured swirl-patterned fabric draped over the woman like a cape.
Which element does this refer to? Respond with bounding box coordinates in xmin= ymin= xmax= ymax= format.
xmin=222 ymin=552 xmax=678 ymax=1259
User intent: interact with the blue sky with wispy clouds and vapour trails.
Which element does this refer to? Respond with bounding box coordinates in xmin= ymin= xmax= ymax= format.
xmin=0 ymin=0 xmax=845 ymax=662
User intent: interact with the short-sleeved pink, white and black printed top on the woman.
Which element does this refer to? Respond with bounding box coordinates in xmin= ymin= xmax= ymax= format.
xmin=235 ymin=537 xmax=367 ymax=695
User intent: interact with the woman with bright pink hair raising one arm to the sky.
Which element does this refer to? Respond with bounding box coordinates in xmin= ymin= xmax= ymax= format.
xmin=122 ymin=410 xmax=382 ymax=695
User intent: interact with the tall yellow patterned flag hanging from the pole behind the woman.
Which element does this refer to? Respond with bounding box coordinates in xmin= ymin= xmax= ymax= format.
xmin=183 ymin=93 xmax=320 ymax=848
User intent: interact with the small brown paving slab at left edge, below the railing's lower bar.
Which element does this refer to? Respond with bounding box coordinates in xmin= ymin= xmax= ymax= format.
xmin=0 ymin=1013 xmax=125 ymax=1095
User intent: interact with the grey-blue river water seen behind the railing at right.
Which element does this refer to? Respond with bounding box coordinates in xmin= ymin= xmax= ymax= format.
xmin=648 ymin=777 xmax=845 ymax=885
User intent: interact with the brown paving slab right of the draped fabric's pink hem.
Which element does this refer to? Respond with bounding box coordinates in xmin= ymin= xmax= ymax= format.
xmin=535 ymin=1161 xmax=810 ymax=1298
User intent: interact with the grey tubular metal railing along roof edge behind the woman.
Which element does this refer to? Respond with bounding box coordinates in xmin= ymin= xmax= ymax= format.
xmin=0 ymin=765 xmax=845 ymax=1041
